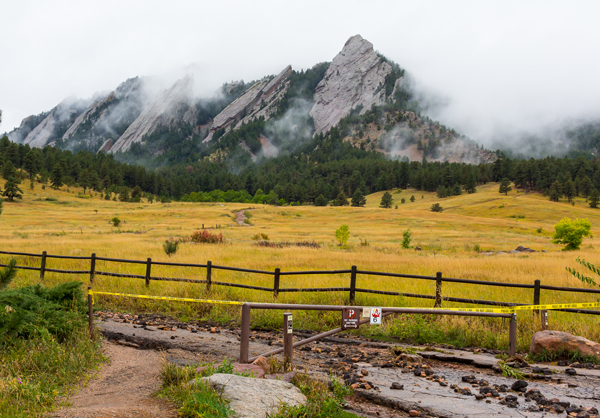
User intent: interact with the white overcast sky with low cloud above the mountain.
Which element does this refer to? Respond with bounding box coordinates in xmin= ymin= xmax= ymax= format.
xmin=0 ymin=0 xmax=600 ymax=143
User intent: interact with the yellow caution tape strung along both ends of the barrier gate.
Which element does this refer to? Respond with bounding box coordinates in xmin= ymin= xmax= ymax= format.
xmin=88 ymin=290 xmax=600 ymax=314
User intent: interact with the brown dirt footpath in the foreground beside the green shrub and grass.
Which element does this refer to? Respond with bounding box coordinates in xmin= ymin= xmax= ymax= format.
xmin=50 ymin=341 xmax=177 ymax=418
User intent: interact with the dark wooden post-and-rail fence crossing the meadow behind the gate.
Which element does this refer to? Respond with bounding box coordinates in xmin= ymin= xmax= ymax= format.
xmin=0 ymin=251 xmax=600 ymax=315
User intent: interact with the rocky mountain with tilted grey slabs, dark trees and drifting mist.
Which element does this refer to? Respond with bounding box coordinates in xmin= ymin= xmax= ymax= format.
xmin=4 ymin=35 xmax=495 ymax=164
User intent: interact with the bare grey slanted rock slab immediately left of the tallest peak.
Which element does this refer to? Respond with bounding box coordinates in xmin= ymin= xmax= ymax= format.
xmin=203 ymin=65 xmax=292 ymax=142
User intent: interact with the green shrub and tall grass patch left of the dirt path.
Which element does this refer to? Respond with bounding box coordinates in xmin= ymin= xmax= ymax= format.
xmin=0 ymin=282 xmax=103 ymax=417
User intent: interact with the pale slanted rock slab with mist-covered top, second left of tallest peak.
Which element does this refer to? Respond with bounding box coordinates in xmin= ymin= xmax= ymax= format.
xmin=106 ymin=75 xmax=194 ymax=153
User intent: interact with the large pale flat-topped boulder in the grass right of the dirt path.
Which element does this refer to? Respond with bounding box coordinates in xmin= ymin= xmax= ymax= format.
xmin=200 ymin=373 xmax=306 ymax=418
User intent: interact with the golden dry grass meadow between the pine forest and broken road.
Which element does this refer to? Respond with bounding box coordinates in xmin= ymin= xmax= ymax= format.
xmin=0 ymin=183 xmax=600 ymax=350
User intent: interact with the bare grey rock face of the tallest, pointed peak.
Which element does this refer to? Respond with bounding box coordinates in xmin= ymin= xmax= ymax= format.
xmin=310 ymin=35 xmax=392 ymax=134
